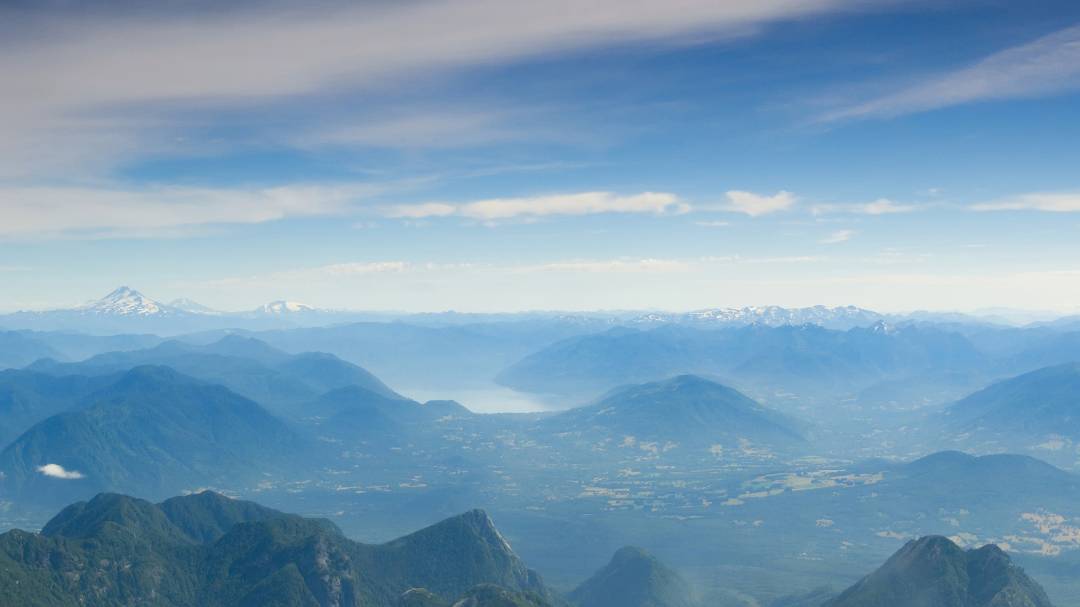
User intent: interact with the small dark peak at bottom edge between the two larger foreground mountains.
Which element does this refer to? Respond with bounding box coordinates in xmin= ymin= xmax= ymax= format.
xmin=569 ymin=547 xmax=697 ymax=607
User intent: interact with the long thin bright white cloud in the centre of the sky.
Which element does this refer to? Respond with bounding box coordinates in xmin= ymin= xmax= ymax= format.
xmin=383 ymin=192 xmax=689 ymax=221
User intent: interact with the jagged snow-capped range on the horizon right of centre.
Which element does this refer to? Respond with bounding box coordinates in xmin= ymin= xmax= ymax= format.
xmin=631 ymin=306 xmax=885 ymax=328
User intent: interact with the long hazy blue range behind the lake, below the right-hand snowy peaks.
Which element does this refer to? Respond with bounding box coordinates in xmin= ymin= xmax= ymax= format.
xmin=497 ymin=322 xmax=987 ymax=396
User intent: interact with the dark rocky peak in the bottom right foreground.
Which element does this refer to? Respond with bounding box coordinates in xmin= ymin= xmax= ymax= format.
xmin=823 ymin=536 xmax=1051 ymax=607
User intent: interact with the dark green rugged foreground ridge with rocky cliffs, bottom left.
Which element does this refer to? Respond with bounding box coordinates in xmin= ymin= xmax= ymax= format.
xmin=0 ymin=493 xmax=561 ymax=607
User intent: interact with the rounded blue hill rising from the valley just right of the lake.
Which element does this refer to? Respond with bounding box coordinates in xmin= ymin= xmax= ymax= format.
xmin=542 ymin=375 xmax=802 ymax=446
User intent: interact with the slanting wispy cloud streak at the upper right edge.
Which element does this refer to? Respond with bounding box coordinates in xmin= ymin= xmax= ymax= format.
xmin=822 ymin=26 xmax=1080 ymax=122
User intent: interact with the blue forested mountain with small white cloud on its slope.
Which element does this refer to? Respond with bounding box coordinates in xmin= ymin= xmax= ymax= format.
xmin=0 ymin=367 xmax=300 ymax=503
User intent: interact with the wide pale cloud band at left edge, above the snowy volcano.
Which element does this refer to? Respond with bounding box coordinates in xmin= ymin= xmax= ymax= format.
xmin=0 ymin=185 xmax=383 ymax=237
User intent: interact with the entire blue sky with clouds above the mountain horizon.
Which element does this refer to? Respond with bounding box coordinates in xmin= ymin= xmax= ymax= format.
xmin=0 ymin=0 xmax=1080 ymax=312
